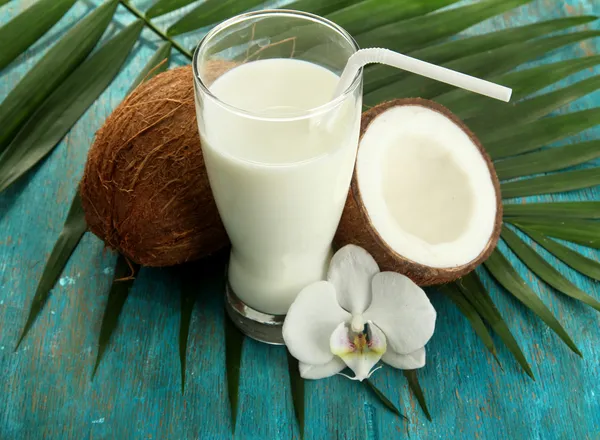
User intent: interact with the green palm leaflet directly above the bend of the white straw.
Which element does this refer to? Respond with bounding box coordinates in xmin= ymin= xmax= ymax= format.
xmin=356 ymin=0 xmax=531 ymax=52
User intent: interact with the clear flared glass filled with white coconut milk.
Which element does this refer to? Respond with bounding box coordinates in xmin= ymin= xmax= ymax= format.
xmin=193 ymin=10 xmax=362 ymax=343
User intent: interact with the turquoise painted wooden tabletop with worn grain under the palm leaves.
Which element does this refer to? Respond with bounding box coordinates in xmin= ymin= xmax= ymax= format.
xmin=0 ymin=0 xmax=600 ymax=440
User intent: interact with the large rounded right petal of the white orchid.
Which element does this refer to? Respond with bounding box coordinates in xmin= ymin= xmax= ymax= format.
xmin=363 ymin=272 xmax=436 ymax=354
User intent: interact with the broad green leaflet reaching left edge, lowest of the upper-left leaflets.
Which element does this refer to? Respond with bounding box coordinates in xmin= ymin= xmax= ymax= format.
xmin=0 ymin=20 xmax=144 ymax=192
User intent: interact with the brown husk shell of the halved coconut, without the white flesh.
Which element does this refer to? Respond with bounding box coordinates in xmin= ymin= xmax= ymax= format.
xmin=335 ymin=98 xmax=502 ymax=286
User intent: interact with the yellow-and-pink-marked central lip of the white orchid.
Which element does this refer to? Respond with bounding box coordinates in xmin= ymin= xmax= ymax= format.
xmin=330 ymin=322 xmax=386 ymax=381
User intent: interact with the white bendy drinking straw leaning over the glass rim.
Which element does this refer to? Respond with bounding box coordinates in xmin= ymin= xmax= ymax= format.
xmin=334 ymin=48 xmax=512 ymax=102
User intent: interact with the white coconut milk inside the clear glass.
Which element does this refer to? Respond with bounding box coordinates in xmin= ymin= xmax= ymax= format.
xmin=199 ymin=59 xmax=361 ymax=314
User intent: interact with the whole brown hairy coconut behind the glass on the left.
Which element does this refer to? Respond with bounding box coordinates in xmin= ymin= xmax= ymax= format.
xmin=80 ymin=66 xmax=228 ymax=266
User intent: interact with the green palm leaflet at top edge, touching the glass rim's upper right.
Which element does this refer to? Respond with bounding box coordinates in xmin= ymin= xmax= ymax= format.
xmin=327 ymin=0 xmax=458 ymax=35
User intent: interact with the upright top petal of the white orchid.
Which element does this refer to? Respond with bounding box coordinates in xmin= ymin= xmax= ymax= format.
xmin=327 ymin=244 xmax=379 ymax=315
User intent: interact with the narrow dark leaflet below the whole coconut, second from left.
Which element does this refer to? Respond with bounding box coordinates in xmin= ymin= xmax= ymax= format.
xmin=92 ymin=255 xmax=140 ymax=378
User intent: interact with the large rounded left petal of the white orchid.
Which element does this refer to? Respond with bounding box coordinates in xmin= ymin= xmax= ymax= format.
xmin=283 ymin=281 xmax=350 ymax=365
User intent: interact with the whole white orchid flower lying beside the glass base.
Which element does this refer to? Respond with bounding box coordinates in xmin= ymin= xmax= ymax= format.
xmin=283 ymin=245 xmax=436 ymax=381
